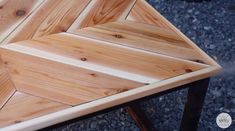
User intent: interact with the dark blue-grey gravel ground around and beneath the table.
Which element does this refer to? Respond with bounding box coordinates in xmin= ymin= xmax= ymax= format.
xmin=47 ymin=0 xmax=235 ymax=131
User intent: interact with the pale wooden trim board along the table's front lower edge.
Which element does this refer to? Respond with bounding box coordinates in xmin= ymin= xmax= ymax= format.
xmin=0 ymin=66 xmax=221 ymax=130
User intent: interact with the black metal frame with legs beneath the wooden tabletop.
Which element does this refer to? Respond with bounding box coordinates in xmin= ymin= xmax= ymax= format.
xmin=41 ymin=78 xmax=210 ymax=131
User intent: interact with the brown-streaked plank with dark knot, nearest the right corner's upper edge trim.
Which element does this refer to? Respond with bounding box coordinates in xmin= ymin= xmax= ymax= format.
xmin=72 ymin=22 xmax=209 ymax=62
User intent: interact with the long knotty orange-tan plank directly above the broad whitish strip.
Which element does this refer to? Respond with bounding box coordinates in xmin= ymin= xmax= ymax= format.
xmin=8 ymin=33 xmax=207 ymax=83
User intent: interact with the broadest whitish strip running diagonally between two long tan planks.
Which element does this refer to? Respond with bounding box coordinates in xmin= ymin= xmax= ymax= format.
xmin=1 ymin=44 xmax=158 ymax=83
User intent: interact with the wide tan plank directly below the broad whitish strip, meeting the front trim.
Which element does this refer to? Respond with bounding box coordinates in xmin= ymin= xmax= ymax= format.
xmin=1 ymin=49 xmax=143 ymax=105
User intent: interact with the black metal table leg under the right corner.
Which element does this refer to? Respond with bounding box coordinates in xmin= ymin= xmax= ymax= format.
xmin=180 ymin=78 xmax=210 ymax=131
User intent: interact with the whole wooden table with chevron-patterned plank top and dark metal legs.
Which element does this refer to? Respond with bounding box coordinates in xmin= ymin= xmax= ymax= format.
xmin=0 ymin=0 xmax=221 ymax=130
